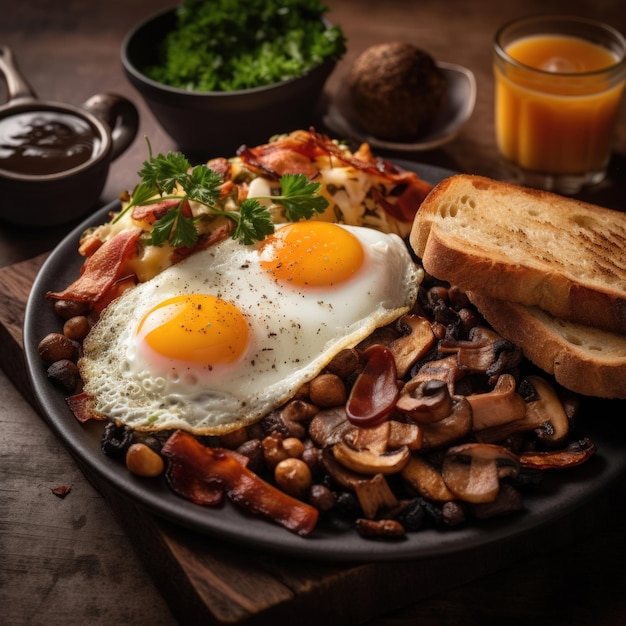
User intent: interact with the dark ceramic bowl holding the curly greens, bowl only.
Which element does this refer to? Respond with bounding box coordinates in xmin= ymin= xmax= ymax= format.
xmin=121 ymin=8 xmax=335 ymax=160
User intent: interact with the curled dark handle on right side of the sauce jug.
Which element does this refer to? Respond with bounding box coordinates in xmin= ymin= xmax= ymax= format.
xmin=83 ymin=93 xmax=139 ymax=161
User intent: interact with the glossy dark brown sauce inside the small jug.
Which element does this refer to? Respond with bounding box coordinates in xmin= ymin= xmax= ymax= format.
xmin=0 ymin=111 xmax=100 ymax=176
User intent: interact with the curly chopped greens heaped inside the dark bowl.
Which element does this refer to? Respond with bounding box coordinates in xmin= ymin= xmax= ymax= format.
xmin=144 ymin=0 xmax=345 ymax=91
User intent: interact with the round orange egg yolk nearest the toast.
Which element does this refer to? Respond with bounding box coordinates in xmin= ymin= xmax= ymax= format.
xmin=259 ymin=221 xmax=365 ymax=287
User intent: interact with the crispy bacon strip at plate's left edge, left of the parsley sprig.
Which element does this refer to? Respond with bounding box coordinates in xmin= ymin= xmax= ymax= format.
xmin=46 ymin=228 xmax=142 ymax=305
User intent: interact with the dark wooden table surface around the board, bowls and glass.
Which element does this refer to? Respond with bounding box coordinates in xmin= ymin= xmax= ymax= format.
xmin=0 ymin=0 xmax=626 ymax=626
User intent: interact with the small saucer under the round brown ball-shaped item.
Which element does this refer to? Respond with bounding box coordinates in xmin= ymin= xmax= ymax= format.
xmin=324 ymin=61 xmax=476 ymax=152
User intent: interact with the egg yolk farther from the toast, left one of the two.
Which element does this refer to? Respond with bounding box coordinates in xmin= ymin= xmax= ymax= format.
xmin=137 ymin=294 xmax=248 ymax=365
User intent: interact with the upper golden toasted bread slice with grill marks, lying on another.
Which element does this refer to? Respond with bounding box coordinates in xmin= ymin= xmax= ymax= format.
xmin=410 ymin=175 xmax=626 ymax=333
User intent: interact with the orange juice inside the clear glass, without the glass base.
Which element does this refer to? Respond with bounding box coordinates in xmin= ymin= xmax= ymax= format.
xmin=495 ymin=35 xmax=624 ymax=175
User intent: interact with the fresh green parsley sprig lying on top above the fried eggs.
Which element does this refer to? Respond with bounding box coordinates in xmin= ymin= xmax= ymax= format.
xmin=114 ymin=142 xmax=328 ymax=247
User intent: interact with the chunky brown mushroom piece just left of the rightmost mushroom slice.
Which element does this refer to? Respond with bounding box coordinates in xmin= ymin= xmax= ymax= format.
xmin=467 ymin=374 xmax=526 ymax=430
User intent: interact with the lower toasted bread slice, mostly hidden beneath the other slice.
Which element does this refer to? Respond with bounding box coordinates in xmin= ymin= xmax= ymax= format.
xmin=467 ymin=291 xmax=626 ymax=398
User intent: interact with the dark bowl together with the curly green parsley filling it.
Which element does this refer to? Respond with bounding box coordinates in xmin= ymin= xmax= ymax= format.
xmin=121 ymin=0 xmax=345 ymax=159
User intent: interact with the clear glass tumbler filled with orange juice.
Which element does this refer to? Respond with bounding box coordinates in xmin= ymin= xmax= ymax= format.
xmin=494 ymin=15 xmax=626 ymax=194
